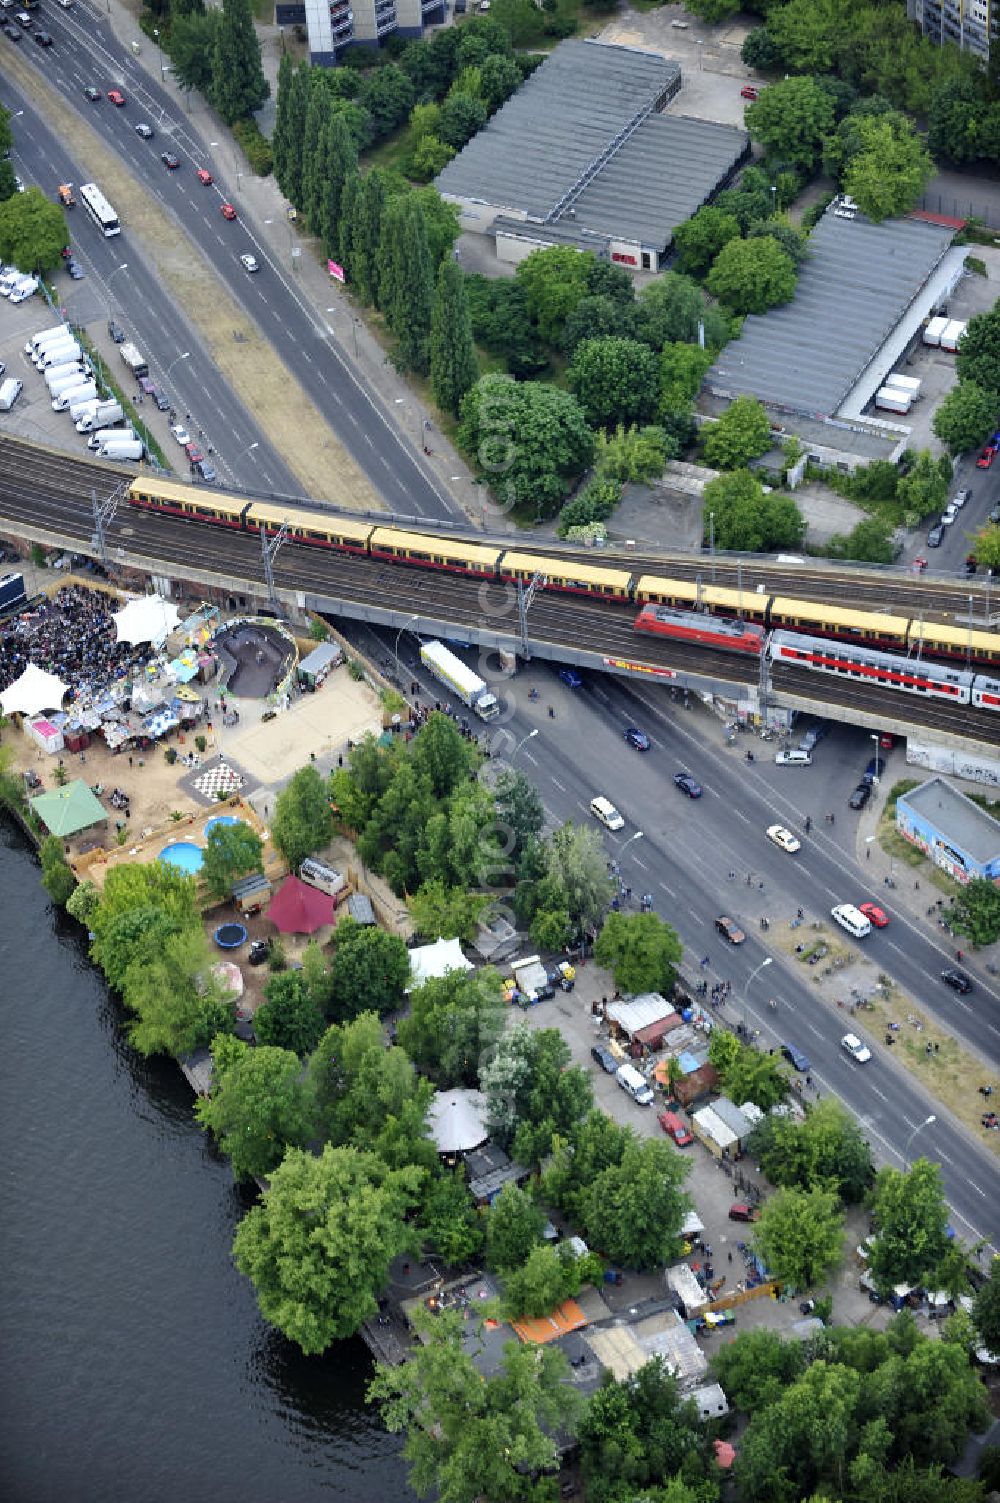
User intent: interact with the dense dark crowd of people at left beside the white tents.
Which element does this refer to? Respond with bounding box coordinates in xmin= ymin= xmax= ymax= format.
xmin=0 ymin=585 xmax=134 ymax=703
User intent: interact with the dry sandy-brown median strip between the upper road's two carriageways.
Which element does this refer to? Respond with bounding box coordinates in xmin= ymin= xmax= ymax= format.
xmin=5 ymin=48 xmax=380 ymax=510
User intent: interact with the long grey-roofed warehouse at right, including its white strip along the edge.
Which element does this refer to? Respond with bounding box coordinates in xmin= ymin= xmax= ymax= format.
xmin=705 ymin=204 xmax=965 ymax=429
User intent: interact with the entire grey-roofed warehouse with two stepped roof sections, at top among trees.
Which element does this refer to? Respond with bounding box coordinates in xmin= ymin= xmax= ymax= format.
xmin=436 ymin=41 xmax=749 ymax=271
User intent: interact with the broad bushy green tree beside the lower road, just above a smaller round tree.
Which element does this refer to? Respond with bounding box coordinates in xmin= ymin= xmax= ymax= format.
xmin=749 ymin=1096 xmax=875 ymax=1204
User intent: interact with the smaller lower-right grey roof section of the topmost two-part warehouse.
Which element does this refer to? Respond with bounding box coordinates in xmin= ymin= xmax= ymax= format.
xmin=559 ymin=114 xmax=749 ymax=249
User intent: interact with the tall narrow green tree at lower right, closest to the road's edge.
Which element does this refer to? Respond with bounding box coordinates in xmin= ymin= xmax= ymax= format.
xmin=869 ymin=1159 xmax=949 ymax=1290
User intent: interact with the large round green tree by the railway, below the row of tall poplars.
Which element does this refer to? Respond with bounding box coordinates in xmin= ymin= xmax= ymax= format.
xmin=459 ymin=372 xmax=594 ymax=517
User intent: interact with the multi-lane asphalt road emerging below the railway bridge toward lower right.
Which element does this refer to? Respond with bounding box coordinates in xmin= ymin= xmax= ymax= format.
xmin=347 ymin=627 xmax=1000 ymax=1247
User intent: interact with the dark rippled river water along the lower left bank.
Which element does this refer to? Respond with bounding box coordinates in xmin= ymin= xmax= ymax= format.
xmin=0 ymin=824 xmax=414 ymax=1503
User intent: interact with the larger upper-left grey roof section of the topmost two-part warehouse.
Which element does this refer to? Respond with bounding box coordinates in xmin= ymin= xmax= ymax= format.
xmin=436 ymin=41 xmax=680 ymax=219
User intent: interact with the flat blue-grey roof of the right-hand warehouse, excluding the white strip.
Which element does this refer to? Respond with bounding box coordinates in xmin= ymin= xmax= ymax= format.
xmin=707 ymin=210 xmax=955 ymax=416
